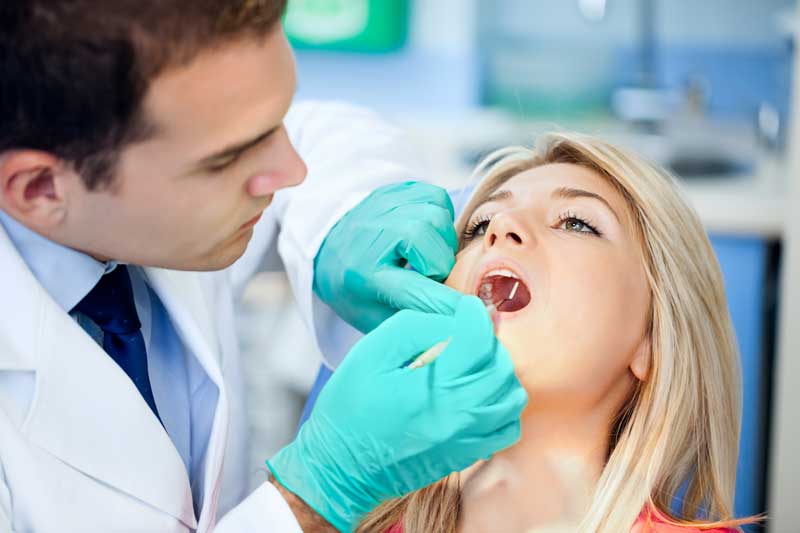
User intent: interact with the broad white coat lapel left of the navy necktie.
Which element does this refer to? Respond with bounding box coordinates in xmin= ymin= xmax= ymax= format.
xmin=0 ymin=222 xmax=196 ymax=528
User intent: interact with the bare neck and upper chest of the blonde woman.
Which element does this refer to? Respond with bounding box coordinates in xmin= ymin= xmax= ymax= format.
xmin=459 ymin=408 xmax=611 ymax=533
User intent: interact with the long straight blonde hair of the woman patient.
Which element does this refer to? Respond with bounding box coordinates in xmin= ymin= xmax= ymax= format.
xmin=356 ymin=133 xmax=753 ymax=533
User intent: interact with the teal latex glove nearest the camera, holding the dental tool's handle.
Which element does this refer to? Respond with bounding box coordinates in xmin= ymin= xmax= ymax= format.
xmin=267 ymin=296 xmax=527 ymax=531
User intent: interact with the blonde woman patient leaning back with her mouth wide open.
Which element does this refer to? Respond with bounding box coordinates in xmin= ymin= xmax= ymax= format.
xmin=358 ymin=134 xmax=749 ymax=533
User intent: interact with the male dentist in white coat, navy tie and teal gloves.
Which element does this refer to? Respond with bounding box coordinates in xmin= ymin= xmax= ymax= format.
xmin=0 ymin=0 xmax=527 ymax=533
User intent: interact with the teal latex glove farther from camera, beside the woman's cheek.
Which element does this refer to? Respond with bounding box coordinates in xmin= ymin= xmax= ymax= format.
xmin=314 ymin=182 xmax=459 ymax=333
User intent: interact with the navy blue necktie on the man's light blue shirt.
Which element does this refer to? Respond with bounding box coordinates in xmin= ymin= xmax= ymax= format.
xmin=73 ymin=265 xmax=161 ymax=421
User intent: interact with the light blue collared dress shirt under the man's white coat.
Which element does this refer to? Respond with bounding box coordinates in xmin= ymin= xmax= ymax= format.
xmin=0 ymin=210 xmax=216 ymax=510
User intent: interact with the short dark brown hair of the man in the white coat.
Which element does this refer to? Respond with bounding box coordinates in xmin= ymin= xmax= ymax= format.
xmin=0 ymin=0 xmax=286 ymax=189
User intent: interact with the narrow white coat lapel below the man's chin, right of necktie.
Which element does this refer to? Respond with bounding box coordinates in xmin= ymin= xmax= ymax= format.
xmin=145 ymin=268 xmax=228 ymax=530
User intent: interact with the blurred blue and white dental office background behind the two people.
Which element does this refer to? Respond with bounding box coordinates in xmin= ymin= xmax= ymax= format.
xmin=241 ymin=0 xmax=800 ymax=533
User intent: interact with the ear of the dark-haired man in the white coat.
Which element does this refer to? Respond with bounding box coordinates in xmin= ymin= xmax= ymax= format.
xmin=0 ymin=150 xmax=73 ymax=233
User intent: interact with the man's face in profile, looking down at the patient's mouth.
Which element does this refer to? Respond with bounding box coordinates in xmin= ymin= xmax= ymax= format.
xmin=48 ymin=27 xmax=306 ymax=270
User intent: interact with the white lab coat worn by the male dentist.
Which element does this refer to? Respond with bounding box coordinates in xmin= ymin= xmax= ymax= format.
xmin=0 ymin=103 xmax=424 ymax=533
